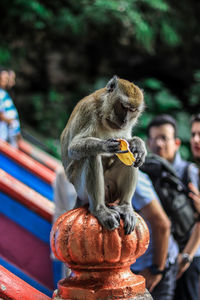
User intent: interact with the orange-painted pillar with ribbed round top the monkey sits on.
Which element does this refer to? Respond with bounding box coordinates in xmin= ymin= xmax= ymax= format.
xmin=51 ymin=207 xmax=152 ymax=300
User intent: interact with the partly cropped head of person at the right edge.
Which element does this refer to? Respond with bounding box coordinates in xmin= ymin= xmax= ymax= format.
xmin=190 ymin=114 xmax=200 ymax=162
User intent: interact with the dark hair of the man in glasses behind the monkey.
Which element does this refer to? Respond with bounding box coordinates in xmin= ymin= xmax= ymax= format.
xmin=147 ymin=114 xmax=177 ymax=137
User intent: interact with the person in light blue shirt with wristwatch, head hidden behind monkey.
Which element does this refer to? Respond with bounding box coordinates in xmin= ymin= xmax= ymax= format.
xmin=131 ymin=171 xmax=178 ymax=300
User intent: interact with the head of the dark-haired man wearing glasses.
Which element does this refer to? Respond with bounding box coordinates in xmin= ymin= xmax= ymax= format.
xmin=147 ymin=114 xmax=181 ymax=162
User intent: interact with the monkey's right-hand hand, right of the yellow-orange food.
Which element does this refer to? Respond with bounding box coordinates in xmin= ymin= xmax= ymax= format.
xmin=128 ymin=137 xmax=147 ymax=168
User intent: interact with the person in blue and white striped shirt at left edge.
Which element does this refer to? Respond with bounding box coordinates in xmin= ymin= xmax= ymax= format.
xmin=0 ymin=68 xmax=21 ymax=147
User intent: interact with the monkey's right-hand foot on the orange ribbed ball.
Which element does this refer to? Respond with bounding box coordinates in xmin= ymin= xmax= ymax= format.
xmin=112 ymin=204 xmax=136 ymax=234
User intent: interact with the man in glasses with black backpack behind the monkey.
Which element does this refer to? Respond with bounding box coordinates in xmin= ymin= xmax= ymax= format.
xmin=145 ymin=115 xmax=200 ymax=300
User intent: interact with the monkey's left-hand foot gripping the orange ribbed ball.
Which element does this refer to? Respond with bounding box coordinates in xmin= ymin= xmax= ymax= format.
xmin=91 ymin=205 xmax=120 ymax=230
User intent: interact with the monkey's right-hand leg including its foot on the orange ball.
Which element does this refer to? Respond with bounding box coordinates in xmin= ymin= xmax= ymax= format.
xmin=106 ymin=161 xmax=138 ymax=234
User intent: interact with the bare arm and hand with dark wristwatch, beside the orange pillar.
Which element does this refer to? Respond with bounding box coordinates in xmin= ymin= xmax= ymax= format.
xmin=140 ymin=199 xmax=171 ymax=292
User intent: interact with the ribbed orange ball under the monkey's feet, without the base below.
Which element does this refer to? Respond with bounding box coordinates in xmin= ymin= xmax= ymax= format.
xmin=51 ymin=207 xmax=149 ymax=269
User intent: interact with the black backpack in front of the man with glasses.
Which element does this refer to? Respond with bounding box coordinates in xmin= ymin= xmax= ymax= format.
xmin=140 ymin=154 xmax=198 ymax=250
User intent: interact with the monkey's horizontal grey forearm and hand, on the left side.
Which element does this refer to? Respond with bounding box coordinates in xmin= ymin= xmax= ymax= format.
xmin=68 ymin=137 xmax=120 ymax=160
